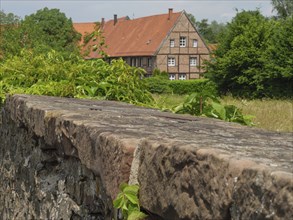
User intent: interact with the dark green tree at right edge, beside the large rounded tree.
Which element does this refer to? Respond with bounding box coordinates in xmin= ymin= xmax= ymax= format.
xmin=262 ymin=16 xmax=293 ymax=97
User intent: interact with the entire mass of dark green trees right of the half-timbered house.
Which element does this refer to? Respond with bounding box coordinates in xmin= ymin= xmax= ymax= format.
xmin=206 ymin=11 xmax=293 ymax=98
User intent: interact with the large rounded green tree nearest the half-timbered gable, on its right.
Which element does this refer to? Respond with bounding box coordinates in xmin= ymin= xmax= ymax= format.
xmin=207 ymin=11 xmax=271 ymax=97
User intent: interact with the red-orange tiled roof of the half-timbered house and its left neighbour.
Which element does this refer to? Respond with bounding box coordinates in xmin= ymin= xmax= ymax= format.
xmin=74 ymin=12 xmax=182 ymax=58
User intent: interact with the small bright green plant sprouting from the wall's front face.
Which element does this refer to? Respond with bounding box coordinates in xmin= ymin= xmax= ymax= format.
xmin=113 ymin=183 xmax=147 ymax=220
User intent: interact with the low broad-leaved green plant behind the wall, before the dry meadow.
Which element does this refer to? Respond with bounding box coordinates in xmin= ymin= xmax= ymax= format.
xmin=174 ymin=93 xmax=253 ymax=126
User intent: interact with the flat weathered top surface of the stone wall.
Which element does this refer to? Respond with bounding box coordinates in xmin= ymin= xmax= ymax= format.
xmin=5 ymin=95 xmax=293 ymax=172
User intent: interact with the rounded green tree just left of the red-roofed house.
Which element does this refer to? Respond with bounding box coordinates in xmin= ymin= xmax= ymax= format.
xmin=21 ymin=8 xmax=80 ymax=52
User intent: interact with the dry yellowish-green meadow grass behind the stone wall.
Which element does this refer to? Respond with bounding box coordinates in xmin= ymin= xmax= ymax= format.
xmin=153 ymin=94 xmax=293 ymax=132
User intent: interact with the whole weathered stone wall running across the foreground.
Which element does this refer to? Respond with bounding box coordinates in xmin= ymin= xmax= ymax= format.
xmin=0 ymin=95 xmax=293 ymax=220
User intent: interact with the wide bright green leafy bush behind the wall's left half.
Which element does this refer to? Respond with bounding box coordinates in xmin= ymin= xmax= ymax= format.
xmin=0 ymin=50 xmax=153 ymax=105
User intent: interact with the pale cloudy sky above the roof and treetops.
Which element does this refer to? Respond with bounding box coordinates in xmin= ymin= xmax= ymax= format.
xmin=0 ymin=0 xmax=275 ymax=23
